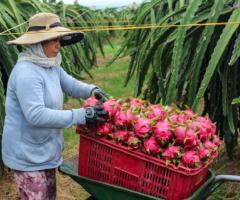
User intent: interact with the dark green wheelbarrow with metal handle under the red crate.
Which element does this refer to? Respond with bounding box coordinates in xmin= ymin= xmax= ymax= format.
xmin=59 ymin=156 xmax=240 ymax=200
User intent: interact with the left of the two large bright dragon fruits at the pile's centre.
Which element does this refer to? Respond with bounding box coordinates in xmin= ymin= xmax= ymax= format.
xmin=134 ymin=118 xmax=151 ymax=138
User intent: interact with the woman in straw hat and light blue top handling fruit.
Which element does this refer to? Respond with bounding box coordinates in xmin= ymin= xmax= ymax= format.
xmin=2 ymin=13 xmax=106 ymax=200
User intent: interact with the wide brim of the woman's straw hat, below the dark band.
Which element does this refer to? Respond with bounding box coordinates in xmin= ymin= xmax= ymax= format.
xmin=7 ymin=27 xmax=84 ymax=46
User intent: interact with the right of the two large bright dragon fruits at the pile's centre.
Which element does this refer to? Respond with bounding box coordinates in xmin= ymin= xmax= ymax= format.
xmin=154 ymin=121 xmax=173 ymax=145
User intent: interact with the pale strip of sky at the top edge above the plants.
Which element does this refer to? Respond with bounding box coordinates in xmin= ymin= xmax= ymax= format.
xmin=63 ymin=0 xmax=144 ymax=8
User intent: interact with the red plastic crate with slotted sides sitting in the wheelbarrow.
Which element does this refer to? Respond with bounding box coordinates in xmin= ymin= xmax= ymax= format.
xmin=79 ymin=134 xmax=215 ymax=200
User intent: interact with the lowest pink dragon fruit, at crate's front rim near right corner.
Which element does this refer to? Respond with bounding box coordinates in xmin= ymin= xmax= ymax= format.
xmin=182 ymin=151 xmax=200 ymax=168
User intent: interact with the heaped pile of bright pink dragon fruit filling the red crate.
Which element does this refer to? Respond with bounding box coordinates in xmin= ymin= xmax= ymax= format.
xmin=80 ymin=97 xmax=221 ymax=169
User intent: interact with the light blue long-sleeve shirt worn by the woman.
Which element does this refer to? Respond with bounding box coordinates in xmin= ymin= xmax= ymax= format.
xmin=2 ymin=61 xmax=96 ymax=171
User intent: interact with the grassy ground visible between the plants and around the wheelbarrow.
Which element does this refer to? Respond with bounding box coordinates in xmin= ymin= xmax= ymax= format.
xmin=0 ymin=39 xmax=240 ymax=200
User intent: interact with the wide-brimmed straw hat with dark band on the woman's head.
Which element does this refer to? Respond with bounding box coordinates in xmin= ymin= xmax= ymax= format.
xmin=7 ymin=12 xmax=84 ymax=46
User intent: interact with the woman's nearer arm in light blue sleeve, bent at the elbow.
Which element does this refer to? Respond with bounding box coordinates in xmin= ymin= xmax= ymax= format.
xmin=16 ymin=69 xmax=86 ymax=128
